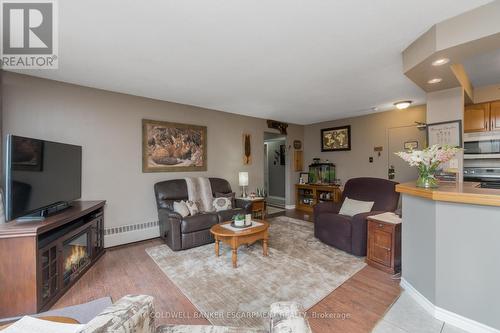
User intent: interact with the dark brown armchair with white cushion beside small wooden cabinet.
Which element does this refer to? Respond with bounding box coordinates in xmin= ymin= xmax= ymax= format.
xmin=314 ymin=178 xmax=399 ymax=256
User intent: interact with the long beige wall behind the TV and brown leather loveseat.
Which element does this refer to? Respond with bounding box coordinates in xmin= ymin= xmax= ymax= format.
xmin=3 ymin=73 xmax=303 ymax=245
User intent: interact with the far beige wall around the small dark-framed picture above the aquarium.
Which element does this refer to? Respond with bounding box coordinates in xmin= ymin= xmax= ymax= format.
xmin=304 ymin=106 xmax=425 ymax=183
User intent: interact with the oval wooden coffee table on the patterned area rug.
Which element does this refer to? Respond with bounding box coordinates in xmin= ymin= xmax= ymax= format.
xmin=210 ymin=220 xmax=269 ymax=268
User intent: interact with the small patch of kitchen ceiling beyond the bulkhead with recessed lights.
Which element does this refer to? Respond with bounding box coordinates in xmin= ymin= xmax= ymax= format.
xmin=463 ymin=48 xmax=500 ymax=88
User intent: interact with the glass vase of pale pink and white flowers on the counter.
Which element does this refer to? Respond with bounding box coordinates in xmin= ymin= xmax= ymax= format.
xmin=396 ymin=145 xmax=461 ymax=188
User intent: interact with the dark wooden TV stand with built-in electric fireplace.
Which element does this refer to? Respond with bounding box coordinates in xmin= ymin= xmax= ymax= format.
xmin=0 ymin=201 xmax=106 ymax=318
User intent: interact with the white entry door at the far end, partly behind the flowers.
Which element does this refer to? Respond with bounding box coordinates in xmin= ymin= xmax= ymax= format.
xmin=387 ymin=126 xmax=426 ymax=183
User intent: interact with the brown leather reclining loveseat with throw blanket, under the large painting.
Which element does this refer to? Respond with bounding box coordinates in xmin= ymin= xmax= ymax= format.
xmin=154 ymin=178 xmax=252 ymax=251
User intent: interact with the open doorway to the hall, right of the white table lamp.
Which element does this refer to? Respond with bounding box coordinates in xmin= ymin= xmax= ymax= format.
xmin=264 ymin=132 xmax=287 ymax=214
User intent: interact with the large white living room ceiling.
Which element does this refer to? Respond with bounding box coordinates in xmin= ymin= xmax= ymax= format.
xmin=10 ymin=0 xmax=490 ymax=124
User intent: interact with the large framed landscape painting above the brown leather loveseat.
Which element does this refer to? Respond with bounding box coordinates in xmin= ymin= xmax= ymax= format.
xmin=142 ymin=119 xmax=207 ymax=172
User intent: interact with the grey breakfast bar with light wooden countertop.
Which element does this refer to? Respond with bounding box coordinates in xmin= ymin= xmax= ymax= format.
xmin=396 ymin=182 xmax=500 ymax=331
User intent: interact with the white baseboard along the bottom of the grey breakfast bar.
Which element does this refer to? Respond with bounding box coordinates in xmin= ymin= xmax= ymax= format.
xmin=400 ymin=278 xmax=500 ymax=333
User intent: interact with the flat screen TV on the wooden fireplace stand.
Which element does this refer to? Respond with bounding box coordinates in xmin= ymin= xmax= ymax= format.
xmin=5 ymin=135 xmax=82 ymax=221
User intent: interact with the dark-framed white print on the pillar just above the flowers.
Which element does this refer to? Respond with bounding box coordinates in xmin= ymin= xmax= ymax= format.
xmin=427 ymin=120 xmax=462 ymax=147
